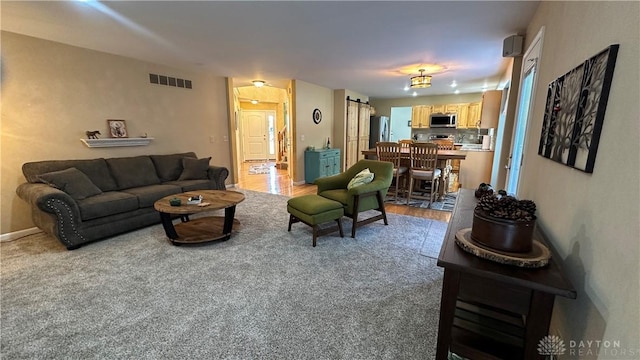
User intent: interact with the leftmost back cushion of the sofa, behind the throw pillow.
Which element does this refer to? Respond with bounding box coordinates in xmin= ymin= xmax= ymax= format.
xmin=22 ymin=158 xmax=118 ymax=191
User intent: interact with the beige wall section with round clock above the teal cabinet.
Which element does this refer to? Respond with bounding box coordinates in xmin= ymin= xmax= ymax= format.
xmin=292 ymin=80 xmax=334 ymax=183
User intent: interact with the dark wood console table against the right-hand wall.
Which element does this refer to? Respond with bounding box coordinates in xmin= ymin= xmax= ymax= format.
xmin=436 ymin=189 xmax=576 ymax=360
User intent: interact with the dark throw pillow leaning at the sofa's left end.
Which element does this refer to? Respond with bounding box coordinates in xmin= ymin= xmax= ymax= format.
xmin=38 ymin=168 xmax=102 ymax=200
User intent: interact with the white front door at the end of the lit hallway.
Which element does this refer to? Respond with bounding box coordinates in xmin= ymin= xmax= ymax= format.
xmin=242 ymin=110 xmax=269 ymax=161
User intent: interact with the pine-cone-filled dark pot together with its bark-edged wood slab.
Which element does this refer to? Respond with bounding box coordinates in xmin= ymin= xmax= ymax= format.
xmin=456 ymin=188 xmax=551 ymax=267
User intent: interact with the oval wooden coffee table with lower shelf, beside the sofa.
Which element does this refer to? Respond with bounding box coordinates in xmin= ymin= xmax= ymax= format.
xmin=153 ymin=190 xmax=244 ymax=245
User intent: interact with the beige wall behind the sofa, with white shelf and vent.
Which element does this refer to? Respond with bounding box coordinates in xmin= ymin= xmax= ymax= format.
xmin=0 ymin=32 xmax=230 ymax=234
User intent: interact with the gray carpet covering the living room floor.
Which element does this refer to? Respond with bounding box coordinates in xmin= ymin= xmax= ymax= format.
xmin=0 ymin=191 xmax=446 ymax=359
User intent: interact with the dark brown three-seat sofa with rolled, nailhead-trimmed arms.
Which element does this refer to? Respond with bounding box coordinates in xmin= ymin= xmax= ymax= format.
xmin=16 ymin=152 xmax=229 ymax=250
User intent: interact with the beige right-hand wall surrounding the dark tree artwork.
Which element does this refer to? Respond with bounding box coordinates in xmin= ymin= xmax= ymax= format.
xmin=519 ymin=1 xmax=640 ymax=348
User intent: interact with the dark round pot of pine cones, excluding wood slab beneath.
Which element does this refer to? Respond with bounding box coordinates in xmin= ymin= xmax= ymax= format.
xmin=471 ymin=192 xmax=536 ymax=253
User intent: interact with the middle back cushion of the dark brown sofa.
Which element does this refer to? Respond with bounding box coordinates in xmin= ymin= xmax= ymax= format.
xmin=106 ymin=156 xmax=160 ymax=190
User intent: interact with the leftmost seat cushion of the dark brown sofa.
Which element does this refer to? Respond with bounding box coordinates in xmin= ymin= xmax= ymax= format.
xmin=78 ymin=191 xmax=138 ymax=221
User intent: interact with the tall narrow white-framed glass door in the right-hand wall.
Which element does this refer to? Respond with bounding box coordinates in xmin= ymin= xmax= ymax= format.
xmin=505 ymin=28 xmax=544 ymax=195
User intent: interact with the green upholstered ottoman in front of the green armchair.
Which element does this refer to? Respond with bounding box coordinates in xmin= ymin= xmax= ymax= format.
xmin=287 ymin=195 xmax=344 ymax=247
